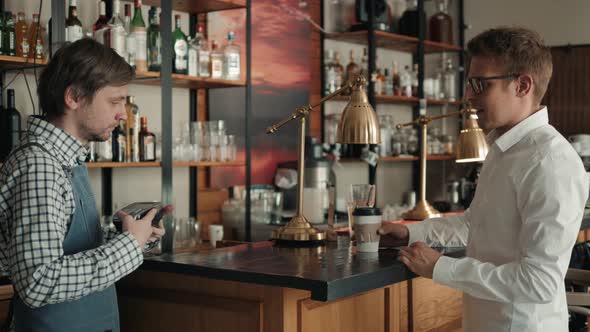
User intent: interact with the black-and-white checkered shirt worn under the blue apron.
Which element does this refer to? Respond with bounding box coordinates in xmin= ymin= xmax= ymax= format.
xmin=0 ymin=117 xmax=143 ymax=307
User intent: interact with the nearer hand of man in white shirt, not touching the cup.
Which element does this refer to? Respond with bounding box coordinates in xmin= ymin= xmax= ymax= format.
xmin=397 ymin=242 xmax=442 ymax=279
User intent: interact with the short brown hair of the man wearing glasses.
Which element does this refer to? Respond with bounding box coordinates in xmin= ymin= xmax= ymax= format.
xmin=467 ymin=27 xmax=553 ymax=102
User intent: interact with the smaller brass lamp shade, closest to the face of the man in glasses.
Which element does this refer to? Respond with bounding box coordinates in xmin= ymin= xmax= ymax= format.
xmin=455 ymin=110 xmax=488 ymax=163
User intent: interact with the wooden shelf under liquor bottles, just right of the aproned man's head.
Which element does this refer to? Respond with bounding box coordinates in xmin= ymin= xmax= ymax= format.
xmin=133 ymin=71 xmax=246 ymax=89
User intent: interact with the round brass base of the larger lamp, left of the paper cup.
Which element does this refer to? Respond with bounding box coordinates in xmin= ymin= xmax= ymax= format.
xmin=271 ymin=215 xmax=326 ymax=246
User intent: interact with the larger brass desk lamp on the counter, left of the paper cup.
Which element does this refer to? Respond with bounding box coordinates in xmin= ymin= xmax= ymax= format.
xmin=266 ymin=76 xmax=381 ymax=245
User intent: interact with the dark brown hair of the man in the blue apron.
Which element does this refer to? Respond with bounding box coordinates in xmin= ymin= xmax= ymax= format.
xmin=37 ymin=38 xmax=135 ymax=119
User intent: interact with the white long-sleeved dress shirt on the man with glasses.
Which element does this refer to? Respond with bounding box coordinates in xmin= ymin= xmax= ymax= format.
xmin=408 ymin=108 xmax=588 ymax=332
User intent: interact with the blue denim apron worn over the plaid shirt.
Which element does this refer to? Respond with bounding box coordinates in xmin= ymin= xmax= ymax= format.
xmin=13 ymin=151 xmax=119 ymax=332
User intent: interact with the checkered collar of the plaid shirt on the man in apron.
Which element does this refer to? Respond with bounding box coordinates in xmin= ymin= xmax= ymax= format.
xmin=27 ymin=116 xmax=88 ymax=166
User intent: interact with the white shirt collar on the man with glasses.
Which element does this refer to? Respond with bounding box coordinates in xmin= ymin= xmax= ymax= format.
xmin=486 ymin=106 xmax=549 ymax=152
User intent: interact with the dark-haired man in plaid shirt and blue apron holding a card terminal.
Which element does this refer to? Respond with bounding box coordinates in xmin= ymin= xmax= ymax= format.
xmin=0 ymin=39 xmax=171 ymax=332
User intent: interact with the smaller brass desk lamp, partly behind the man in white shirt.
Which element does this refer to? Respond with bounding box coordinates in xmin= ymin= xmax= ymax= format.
xmin=396 ymin=106 xmax=488 ymax=220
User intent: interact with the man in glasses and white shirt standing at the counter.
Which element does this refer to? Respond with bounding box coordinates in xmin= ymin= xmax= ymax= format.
xmin=379 ymin=27 xmax=588 ymax=332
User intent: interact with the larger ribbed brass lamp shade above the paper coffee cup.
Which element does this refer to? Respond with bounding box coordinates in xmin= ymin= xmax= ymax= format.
xmin=337 ymin=84 xmax=381 ymax=144
